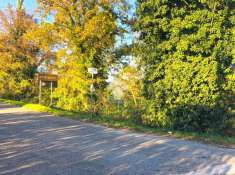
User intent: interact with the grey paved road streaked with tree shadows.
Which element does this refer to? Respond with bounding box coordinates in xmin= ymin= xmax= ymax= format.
xmin=0 ymin=104 xmax=235 ymax=175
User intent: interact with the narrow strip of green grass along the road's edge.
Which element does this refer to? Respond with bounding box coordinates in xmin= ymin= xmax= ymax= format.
xmin=0 ymin=99 xmax=235 ymax=148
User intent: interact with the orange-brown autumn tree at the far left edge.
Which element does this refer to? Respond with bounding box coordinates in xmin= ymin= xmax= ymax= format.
xmin=0 ymin=0 xmax=51 ymax=99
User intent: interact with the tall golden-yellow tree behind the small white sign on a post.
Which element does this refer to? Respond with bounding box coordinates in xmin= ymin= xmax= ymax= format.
xmin=38 ymin=0 xmax=130 ymax=110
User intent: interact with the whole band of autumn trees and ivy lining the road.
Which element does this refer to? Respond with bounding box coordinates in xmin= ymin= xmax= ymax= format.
xmin=0 ymin=0 xmax=235 ymax=136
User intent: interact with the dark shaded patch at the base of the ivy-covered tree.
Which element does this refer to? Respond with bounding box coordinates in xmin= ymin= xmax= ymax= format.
xmin=167 ymin=104 xmax=232 ymax=132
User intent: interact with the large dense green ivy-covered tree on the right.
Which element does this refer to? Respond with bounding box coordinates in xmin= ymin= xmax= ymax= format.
xmin=135 ymin=0 xmax=235 ymax=131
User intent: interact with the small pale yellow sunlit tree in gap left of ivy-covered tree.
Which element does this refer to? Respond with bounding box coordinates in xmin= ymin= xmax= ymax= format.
xmin=106 ymin=64 xmax=144 ymax=122
